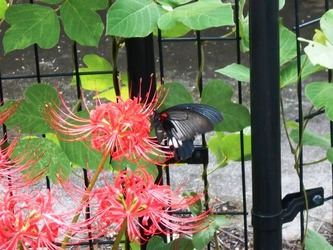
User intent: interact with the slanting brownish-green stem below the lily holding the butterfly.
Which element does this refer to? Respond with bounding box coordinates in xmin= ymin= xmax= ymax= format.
xmin=61 ymin=153 xmax=109 ymax=249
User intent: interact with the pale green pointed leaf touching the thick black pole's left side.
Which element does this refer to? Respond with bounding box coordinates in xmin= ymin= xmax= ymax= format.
xmin=215 ymin=63 xmax=250 ymax=82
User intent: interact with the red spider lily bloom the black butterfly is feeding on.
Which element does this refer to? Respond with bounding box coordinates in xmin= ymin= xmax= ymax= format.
xmin=44 ymin=89 xmax=172 ymax=164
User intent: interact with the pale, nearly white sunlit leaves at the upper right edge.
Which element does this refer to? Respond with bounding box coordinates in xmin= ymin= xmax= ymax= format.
xmin=299 ymin=10 xmax=333 ymax=69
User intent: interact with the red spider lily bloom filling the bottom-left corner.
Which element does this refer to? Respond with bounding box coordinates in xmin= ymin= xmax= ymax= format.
xmin=0 ymin=191 xmax=72 ymax=250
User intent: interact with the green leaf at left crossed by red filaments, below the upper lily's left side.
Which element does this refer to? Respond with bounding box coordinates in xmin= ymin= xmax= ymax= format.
xmin=14 ymin=138 xmax=71 ymax=183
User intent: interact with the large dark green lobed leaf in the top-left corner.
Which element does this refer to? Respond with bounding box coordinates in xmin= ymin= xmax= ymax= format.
xmin=3 ymin=4 xmax=60 ymax=53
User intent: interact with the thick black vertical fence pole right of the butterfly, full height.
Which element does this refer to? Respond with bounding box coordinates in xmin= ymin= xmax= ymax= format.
xmin=249 ymin=0 xmax=282 ymax=250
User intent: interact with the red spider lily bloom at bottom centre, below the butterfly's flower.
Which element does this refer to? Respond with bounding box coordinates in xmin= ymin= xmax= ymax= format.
xmin=89 ymin=168 xmax=211 ymax=242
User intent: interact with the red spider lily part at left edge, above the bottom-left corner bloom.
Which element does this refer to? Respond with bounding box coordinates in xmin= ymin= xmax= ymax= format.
xmin=0 ymin=136 xmax=42 ymax=188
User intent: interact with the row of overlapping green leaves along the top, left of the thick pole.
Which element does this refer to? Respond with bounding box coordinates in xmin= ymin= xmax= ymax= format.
xmin=0 ymin=0 xmax=234 ymax=53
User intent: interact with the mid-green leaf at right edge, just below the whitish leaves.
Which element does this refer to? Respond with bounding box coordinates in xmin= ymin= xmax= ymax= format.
xmin=305 ymin=82 xmax=333 ymax=121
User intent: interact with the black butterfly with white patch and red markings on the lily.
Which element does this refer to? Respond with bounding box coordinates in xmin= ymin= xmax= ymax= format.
xmin=153 ymin=103 xmax=223 ymax=160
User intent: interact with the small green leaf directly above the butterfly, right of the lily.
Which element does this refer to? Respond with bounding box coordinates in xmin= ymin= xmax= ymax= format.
xmin=160 ymin=82 xmax=193 ymax=110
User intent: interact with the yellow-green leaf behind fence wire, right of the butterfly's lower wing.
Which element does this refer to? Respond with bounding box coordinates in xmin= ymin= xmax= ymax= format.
xmin=221 ymin=133 xmax=251 ymax=161
